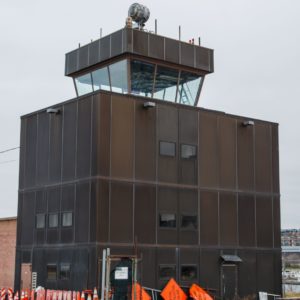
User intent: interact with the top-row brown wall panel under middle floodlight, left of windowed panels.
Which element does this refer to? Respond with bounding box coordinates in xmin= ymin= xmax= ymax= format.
xmin=135 ymin=102 xmax=157 ymax=181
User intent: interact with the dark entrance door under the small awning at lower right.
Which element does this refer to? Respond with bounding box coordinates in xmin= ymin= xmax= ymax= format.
xmin=222 ymin=264 xmax=237 ymax=300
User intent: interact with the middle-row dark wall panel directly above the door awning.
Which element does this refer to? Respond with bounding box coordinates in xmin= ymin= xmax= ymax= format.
xmin=219 ymin=193 xmax=237 ymax=246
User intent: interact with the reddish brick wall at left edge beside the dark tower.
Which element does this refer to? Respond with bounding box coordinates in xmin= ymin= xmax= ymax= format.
xmin=0 ymin=218 xmax=17 ymax=288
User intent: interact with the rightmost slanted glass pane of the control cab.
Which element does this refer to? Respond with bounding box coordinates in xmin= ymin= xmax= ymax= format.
xmin=177 ymin=71 xmax=201 ymax=105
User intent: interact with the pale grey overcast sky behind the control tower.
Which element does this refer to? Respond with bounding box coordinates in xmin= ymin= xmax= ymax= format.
xmin=0 ymin=0 xmax=300 ymax=228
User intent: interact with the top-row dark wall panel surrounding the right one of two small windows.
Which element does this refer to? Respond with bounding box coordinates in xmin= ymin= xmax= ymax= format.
xmin=178 ymin=109 xmax=199 ymax=185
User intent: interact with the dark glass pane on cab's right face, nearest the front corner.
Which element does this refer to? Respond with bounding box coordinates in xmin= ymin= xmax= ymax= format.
xmin=130 ymin=60 xmax=155 ymax=97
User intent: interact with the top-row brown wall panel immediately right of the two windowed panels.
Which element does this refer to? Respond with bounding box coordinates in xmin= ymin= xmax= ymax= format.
xmin=199 ymin=112 xmax=219 ymax=187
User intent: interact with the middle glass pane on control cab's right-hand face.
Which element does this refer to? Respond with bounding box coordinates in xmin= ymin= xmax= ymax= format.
xmin=153 ymin=66 xmax=179 ymax=102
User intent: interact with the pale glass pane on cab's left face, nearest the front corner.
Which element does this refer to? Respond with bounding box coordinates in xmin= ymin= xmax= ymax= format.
xmin=109 ymin=60 xmax=128 ymax=94
